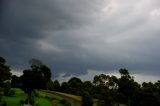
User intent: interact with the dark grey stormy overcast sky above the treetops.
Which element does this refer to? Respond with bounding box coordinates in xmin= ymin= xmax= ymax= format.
xmin=0 ymin=0 xmax=160 ymax=80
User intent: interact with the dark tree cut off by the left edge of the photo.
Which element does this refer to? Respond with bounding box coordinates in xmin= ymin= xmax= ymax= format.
xmin=0 ymin=57 xmax=12 ymax=87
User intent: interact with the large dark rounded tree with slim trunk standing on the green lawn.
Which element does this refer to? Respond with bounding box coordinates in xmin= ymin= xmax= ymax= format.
xmin=20 ymin=59 xmax=51 ymax=104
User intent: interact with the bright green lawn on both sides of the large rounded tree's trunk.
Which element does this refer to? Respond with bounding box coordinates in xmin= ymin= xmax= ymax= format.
xmin=2 ymin=88 xmax=64 ymax=106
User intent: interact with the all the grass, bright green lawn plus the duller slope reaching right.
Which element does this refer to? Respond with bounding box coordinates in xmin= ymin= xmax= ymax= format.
xmin=2 ymin=88 xmax=125 ymax=106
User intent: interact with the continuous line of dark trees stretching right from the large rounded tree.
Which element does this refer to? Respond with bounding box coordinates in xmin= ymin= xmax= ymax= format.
xmin=53 ymin=69 xmax=160 ymax=106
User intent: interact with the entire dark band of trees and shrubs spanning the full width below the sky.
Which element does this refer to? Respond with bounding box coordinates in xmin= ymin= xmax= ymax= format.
xmin=0 ymin=57 xmax=160 ymax=106
